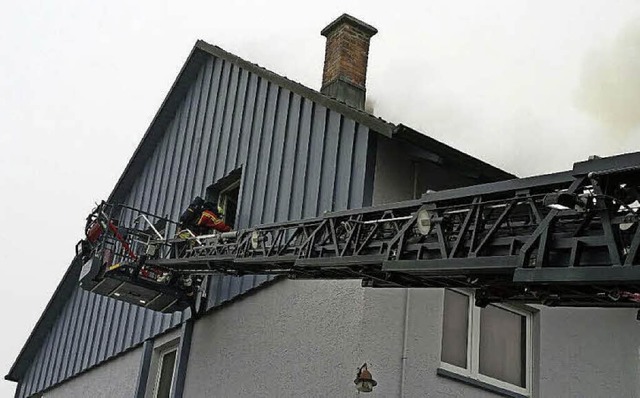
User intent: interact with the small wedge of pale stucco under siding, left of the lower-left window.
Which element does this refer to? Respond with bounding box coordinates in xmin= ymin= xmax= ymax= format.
xmin=43 ymin=347 xmax=142 ymax=398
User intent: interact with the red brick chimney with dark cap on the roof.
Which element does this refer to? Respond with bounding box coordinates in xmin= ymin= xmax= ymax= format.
xmin=320 ymin=14 xmax=378 ymax=110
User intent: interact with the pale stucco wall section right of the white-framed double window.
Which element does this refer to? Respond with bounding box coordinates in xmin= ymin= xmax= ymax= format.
xmin=540 ymin=308 xmax=640 ymax=398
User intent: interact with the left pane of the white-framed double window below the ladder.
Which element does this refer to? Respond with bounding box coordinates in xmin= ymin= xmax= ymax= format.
xmin=441 ymin=290 xmax=469 ymax=369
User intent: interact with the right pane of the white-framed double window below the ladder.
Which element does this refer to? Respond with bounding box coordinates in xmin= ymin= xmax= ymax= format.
xmin=480 ymin=305 xmax=527 ymax=388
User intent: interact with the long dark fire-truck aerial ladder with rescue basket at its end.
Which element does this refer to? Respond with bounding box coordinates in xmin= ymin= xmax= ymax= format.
xmin=76 ymin=152 xmax=640 ymax=312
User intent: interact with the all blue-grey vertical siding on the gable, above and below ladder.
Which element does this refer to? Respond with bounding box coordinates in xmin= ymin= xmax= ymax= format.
xmin=17 ymin=56 xmax=370 ymax=397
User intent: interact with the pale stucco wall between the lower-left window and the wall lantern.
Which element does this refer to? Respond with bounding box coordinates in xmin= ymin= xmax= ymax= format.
xmin=184 ymin=280 xmax=363 ymax=398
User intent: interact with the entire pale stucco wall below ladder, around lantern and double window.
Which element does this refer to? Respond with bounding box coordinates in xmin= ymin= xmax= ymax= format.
xmin=180 ymin=281 xmax=640 ymax=398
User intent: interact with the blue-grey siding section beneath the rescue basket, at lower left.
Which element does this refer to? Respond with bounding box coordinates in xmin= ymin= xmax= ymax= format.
xmin=16 ymin=289 xmax=183 ymax=397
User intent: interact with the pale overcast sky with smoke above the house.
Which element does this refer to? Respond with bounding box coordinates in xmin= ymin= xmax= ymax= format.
xmin=0 ymin=0 xmax=640 ymax=396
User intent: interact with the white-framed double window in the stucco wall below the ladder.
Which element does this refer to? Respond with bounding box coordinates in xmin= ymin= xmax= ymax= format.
xmin=440 ymin=289 xmax=532 ymax=395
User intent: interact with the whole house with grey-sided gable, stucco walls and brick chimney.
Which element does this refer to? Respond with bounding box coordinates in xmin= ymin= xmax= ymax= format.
xmin=6 ymin=15 xmax=640 ymax=398
